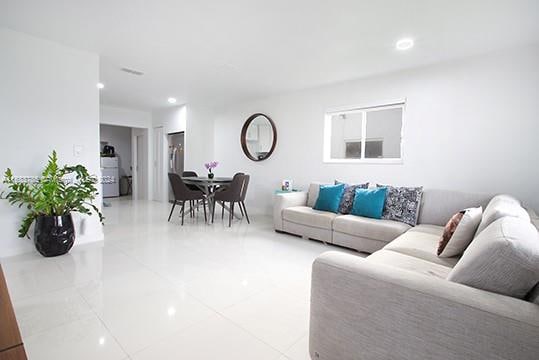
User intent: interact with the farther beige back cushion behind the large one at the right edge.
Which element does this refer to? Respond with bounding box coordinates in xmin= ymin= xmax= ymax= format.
xmin=475 ymin=195 xmax=530 ymax=236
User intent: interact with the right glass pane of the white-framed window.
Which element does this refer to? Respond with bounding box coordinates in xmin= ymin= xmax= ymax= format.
xmin=365 ymin=108 xmax=402 ymax=159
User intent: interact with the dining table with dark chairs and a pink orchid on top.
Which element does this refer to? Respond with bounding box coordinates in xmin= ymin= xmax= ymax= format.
xmin=168 ymin=170 xmax=250 ymax=227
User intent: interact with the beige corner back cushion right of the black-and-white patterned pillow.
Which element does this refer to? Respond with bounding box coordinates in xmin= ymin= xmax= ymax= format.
xmin=417 ymin=189 xmax=492 ymax=226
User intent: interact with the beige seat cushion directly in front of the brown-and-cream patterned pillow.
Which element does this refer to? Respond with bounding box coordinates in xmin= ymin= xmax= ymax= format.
xmin=384 ymin=225 xmax=459 ymax=268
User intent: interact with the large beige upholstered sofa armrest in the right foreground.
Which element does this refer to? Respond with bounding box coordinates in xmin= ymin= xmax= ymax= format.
xmin=309 ymin=252 xmax=539 ymax=360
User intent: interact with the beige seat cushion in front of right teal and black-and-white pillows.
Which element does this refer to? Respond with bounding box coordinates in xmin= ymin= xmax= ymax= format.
xmin=333 ymin=215 xmax=411 ymax=242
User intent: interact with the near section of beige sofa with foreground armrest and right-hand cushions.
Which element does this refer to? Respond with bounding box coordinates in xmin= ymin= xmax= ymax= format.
xmin=309 ymin=195 xmax=539 ymax=360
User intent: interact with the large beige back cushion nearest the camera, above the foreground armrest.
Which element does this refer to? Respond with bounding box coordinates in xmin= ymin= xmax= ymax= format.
xmin=447 ymin=216 xmax=539 ymax=299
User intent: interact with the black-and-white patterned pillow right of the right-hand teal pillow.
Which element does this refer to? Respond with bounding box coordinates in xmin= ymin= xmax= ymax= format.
xmin=376 ymin=184 xmax=423 ymax=226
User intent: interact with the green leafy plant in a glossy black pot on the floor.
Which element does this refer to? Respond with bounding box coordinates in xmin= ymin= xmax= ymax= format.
xmin=2 ymin=151 xmax=103 ymax=257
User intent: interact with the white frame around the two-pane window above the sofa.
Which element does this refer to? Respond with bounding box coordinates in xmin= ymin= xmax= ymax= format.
xmin=324 ymin=99 xmax=406 ymax=164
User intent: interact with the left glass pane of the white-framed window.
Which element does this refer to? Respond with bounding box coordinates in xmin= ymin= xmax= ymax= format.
xmin=331 ymin=111 xmax=363 ymax=159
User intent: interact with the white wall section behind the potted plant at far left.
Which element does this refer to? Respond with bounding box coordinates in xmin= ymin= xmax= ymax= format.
xmin=0 ymin=29 xmax=103 ymax=257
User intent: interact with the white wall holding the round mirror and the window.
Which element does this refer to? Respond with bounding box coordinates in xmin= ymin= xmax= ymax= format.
xmin=214 ymin=46 xmax=539 ymax=213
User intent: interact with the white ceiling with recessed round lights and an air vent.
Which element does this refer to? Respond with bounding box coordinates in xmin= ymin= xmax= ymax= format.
xmin=0 ymin=0 xmax=539 ymax=109
